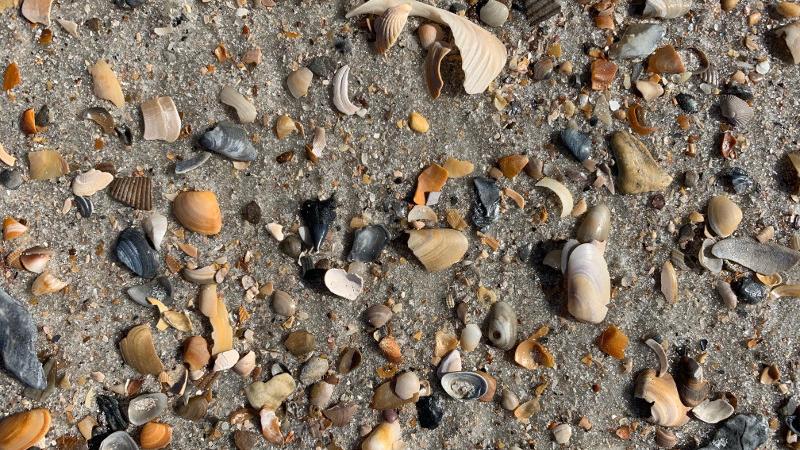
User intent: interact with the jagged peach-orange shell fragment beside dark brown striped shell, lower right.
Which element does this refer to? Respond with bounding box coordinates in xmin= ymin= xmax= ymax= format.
xmin=634 ymin=369 xmax=689 ymax=427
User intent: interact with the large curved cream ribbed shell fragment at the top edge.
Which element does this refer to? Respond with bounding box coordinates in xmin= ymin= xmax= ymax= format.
xmin=346 ymin=0 xmax=507 ymax=94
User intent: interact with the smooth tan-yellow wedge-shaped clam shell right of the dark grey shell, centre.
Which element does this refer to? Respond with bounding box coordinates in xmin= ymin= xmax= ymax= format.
xmin=408 ymin=228 xmax=469 ymax=272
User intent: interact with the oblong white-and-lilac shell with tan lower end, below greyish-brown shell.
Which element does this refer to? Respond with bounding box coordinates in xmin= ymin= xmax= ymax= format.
xmin=567 ymin=243 xmax=611 ymax=323
